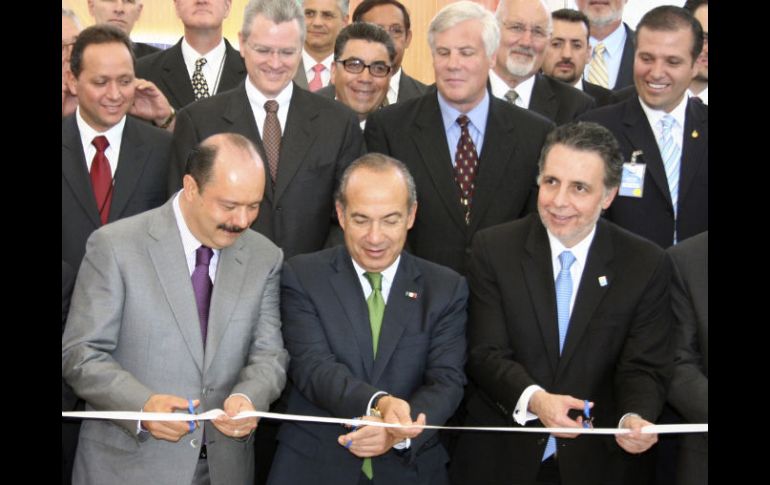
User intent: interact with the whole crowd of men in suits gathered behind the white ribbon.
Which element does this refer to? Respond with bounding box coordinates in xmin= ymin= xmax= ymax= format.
xmin=62 ymin=0 xmax=708 ymax=485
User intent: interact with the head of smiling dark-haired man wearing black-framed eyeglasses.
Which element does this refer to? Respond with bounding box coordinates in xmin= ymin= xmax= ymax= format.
xmin=317 ymin=22 xmax=396 ymax=129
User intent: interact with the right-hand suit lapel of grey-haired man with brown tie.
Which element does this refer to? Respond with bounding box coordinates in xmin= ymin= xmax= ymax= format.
xmin=274 ymin=86 xmax=320 ymax=201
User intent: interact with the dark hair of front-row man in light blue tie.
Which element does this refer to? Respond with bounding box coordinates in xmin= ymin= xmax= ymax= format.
xmin=537 ymin=121 xmax=623 ymax=189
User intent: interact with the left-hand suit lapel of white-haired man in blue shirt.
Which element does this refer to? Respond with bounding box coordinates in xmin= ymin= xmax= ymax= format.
xmin=412 ymin=95 xmax=467 ymax=231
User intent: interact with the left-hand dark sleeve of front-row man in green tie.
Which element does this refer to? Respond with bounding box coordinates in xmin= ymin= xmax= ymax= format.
xmin=281 ymin=262 xmax=379 ymax=417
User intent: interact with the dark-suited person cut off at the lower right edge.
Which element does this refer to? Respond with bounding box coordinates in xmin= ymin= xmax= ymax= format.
xmin=668 ymin=231 xmax=709 ymax=485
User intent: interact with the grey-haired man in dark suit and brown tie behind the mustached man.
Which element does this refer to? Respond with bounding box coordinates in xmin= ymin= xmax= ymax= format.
xmin=169 ymin=0 xmax=363 ymax=257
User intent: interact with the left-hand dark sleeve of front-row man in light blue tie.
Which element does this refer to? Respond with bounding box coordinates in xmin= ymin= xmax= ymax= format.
xmin=468 ymin=233 xmax=537 ymax=412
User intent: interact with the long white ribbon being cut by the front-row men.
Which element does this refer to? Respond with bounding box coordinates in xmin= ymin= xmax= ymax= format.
xmin=61 ymin=409 xmax=709 ymax=434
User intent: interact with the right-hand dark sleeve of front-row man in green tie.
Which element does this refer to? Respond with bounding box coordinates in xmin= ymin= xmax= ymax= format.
xmin=409 ymin=277 xmax=468 ymax=452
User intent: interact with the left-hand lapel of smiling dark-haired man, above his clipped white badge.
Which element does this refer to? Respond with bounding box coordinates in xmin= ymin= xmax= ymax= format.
xmin=623 ymin=96 xmax=671 ymax=205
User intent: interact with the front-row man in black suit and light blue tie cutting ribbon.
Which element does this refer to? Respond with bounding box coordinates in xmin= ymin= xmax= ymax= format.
xmin=451 ymin=123 xmax=673 ymax=485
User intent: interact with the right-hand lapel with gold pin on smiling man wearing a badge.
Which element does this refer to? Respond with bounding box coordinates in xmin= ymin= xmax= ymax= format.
xmin=679 ymin=101 xmax=708 ymax=200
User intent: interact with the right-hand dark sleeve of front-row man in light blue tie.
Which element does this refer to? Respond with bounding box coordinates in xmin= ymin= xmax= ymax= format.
xmin=615 ymin=253 xmax=674 ymax=421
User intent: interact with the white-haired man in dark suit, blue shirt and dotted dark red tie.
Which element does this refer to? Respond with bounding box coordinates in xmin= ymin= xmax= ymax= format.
xmin=365 ymin=1 xmax=553 ymax=274
